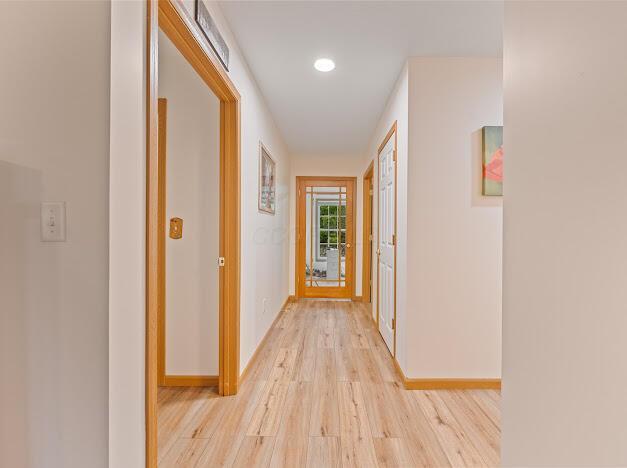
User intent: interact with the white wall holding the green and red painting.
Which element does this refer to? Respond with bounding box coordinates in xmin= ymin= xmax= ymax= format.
xmin=399 ymin=58 xmax=507 ymax=378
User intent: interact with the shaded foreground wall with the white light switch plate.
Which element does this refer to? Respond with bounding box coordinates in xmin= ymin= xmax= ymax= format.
xmin=0 ymin=2 xmax=110 ymax=468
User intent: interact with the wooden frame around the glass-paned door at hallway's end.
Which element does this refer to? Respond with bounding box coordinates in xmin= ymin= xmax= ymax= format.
xmin=294 ymin=176 xmax=357 ymax=300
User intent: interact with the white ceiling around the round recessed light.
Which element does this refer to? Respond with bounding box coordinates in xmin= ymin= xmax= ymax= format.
xmin=220 ymin=0 xmax=503 ymax=154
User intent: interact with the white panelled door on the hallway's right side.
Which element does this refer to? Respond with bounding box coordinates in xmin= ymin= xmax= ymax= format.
xmin=377 ymin=137 xmax=396 ymax=354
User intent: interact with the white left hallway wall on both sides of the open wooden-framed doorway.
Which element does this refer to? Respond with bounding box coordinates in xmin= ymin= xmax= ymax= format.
xmin=109 ymin=2 xmax=290 ymax=467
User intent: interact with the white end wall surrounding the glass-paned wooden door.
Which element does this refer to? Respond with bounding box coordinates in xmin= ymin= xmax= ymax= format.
xmin=289 ymin=154 xmax=365 ymax=296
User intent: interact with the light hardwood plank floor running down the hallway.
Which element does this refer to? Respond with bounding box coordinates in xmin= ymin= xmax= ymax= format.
xmin=159 ymin=301 xmax=501 ymax=468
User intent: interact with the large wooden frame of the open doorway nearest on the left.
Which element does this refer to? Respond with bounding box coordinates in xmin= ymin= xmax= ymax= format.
xmin=145 ymin=0 xmax=241 ymax=468
